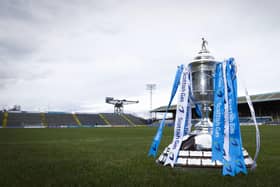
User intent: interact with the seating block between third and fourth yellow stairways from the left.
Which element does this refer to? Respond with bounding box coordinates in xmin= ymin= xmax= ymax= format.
xmin=76 ymin=113 xmax=107 ymax=126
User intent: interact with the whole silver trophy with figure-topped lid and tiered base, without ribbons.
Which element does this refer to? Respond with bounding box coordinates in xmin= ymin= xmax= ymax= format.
xmin=157 ymin=38 xmax=253 ymax=167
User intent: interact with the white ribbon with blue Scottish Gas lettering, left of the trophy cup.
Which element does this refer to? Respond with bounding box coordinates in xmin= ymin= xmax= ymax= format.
xmin=164 ymin=66 xmax=190 ymax=167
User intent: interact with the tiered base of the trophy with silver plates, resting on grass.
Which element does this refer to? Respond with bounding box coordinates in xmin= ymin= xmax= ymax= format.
xmin=156 ymin=133 xmax=253 ymax=168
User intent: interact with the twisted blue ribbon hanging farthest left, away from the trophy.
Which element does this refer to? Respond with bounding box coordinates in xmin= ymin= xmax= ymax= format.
xmin=148 ymin=65 xmax=184 ymax=157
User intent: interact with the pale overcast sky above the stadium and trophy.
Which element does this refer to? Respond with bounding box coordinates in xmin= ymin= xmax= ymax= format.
xmin=0 ymin=0 xmax=280 ymax=115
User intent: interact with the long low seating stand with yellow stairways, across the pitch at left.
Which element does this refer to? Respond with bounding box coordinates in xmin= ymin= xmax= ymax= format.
xmin=0 ymin=111 xmax=148 ymax=128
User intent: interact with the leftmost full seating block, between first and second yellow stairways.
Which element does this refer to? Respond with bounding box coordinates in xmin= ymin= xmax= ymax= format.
xmin=7 ymin=112 xmax=43 ymax=127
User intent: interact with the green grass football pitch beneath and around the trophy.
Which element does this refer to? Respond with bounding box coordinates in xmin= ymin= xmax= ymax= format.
xmin=0 ymin=126 xmax=280 ymax=187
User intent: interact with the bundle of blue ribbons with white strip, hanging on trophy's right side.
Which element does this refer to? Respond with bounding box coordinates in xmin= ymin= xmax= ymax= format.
xmin=212 ymin=58 xmax=247 ymax=176
